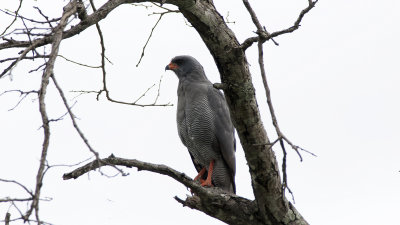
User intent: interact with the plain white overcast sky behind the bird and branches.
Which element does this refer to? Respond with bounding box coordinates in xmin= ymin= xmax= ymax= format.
xmin=0 ymin=0 xmax=400 ymax=225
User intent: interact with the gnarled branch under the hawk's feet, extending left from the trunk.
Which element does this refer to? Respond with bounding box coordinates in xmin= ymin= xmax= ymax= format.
xmin=63 ymin=155 xmax=263 ymax=225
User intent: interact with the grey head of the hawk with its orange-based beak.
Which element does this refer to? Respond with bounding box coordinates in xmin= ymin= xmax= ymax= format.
xmin=165 ymin=55 xmax=208 ymax=81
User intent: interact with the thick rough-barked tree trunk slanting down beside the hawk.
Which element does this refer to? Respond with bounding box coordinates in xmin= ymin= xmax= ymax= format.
xmin=174 ymin=0 xmax=307 ymax=224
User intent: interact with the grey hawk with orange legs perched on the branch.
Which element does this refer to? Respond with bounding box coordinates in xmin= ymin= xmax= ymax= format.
xmin=165 ymin=55 xmax=236 ymax=193
